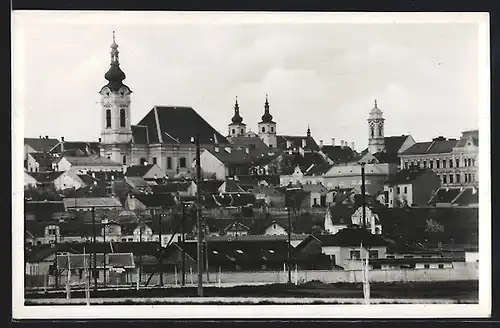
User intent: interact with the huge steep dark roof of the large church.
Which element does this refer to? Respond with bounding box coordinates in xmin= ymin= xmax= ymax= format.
xmin=138 ymin=106 xmax=228 ymax=144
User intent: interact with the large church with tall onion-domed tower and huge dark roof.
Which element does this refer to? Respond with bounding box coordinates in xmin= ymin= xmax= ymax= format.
xmin=99 ymin=32 xmax=228 ymax=176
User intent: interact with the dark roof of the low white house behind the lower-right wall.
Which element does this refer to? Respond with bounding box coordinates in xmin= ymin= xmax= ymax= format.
xmin=316 ymin=227 xmax=388 ymax=247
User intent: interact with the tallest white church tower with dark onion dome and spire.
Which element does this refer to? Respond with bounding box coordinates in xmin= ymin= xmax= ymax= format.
xmin=99 ymin=31 xmax=132 ymax=165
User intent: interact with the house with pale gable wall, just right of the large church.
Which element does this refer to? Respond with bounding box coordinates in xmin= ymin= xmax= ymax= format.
xmin=200 ymin=146 xmax=252 ymax=180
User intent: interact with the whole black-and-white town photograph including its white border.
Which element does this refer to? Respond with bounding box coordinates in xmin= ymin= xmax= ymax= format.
xmin=12 ymin=11 xmax=491 ymax=319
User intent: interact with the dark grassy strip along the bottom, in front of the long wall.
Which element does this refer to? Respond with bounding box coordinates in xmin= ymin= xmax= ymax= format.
xmin=25 ymin=281 xmax=478 ymax=305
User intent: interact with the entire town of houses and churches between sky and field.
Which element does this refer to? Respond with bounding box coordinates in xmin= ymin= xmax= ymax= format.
xmin=24 ymin=35 xmax=479 ymax=289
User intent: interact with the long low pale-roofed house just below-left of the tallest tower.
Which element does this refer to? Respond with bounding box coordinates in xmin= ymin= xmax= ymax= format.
xmin=52 ymin=156 xmax=123 ymax=173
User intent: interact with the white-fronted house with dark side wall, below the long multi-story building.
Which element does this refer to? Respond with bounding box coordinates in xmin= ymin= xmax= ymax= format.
xmin=384 ymin=167 xmax=441 ymax=207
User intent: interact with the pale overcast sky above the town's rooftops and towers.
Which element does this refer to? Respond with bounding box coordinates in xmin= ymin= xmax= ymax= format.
xmin=13 ymin=13 xmax=479 ymax=150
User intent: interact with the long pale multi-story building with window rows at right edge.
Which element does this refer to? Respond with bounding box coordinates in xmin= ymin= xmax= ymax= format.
xmin=399 ymin=130 xmax=479 ymax=187
